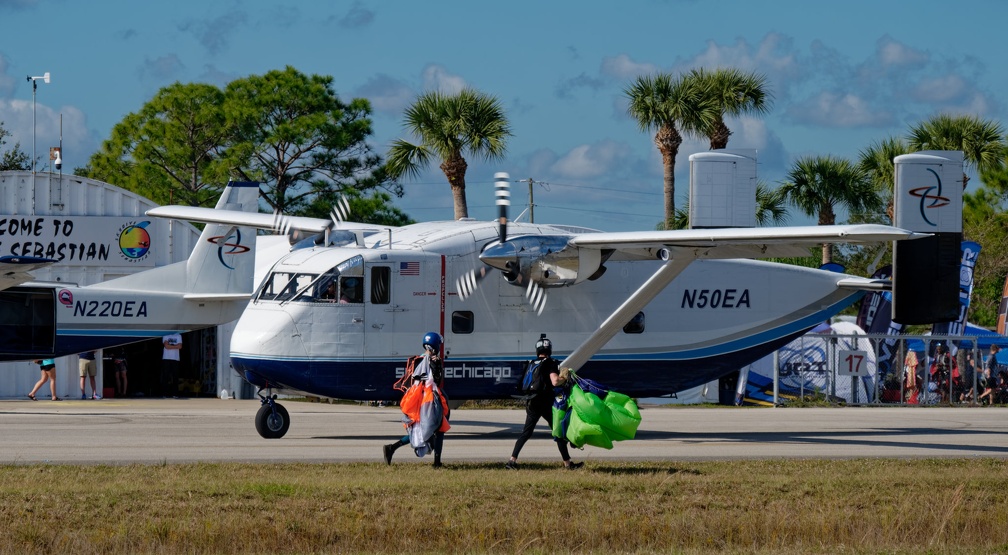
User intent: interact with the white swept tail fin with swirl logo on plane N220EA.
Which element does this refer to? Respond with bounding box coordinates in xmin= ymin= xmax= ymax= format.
xmin=185 ymin=181 xmax=259 ymax=300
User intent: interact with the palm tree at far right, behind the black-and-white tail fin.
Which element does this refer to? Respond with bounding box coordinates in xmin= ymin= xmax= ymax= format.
xmin=908 ymin=114 xmax=1005 ymax=188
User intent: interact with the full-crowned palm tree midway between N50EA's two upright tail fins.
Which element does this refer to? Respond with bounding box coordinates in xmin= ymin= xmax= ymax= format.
xmin=780 ymin=156 xmax=882 ymax=264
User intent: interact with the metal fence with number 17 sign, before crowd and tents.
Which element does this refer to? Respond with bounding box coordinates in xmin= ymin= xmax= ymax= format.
xmin=753 ymin=334 xmax=1008 ymax=405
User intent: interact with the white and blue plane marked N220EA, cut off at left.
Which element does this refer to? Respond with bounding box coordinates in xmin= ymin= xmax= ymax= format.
xmin=0 ymin=183 xmax=259 ymax=361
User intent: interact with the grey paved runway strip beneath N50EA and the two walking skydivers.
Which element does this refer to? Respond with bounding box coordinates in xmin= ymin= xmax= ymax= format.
xmin=0 ymin=399 xmax=1008 ymax=464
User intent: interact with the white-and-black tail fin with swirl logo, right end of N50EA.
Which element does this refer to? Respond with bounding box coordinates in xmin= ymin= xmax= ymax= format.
xmin=892 ymin=150 xmax=963 ymax=324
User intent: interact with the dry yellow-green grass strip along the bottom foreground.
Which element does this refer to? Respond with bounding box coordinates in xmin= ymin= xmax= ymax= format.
xmin=0 ymin=459 xmax=1008 ymax=554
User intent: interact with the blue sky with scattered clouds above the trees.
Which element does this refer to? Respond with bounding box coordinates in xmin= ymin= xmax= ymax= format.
xmin=0 ymin=0 xmax=1008 ymax=231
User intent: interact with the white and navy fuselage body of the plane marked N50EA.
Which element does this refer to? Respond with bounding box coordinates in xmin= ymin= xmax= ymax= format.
xmin=231 ymin=222 xmax=862 ymax=400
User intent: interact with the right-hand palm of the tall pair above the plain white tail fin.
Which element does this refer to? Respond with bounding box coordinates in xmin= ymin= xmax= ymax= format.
xmin=686 ymin=67 xmax=773 ymax=150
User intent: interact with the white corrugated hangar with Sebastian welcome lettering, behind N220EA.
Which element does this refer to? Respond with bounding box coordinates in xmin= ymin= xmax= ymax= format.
xmin=0 ymin=171 xmax=250 ymax=399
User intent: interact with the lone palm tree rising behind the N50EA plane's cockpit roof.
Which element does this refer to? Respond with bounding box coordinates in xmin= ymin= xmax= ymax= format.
xmin=386 ymin=88 xmax=511 ymax=220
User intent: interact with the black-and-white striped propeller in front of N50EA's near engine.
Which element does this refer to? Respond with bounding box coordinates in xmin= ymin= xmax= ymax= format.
xmin=456 ymin=171 xmax=546 ymax=314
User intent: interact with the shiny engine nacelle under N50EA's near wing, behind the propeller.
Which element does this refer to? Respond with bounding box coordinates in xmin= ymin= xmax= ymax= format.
xmin=480 ymin=235 xmax=604 ymax=287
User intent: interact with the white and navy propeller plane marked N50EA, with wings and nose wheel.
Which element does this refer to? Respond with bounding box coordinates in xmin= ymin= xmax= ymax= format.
xmin=147 ymin=174 xmax=927 ymax=438
